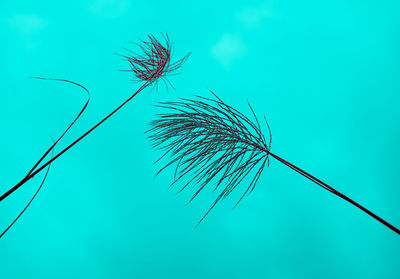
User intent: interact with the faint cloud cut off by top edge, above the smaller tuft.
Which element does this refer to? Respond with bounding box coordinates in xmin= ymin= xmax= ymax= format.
xmin=89 ymin=0 xmax=130 ymax=18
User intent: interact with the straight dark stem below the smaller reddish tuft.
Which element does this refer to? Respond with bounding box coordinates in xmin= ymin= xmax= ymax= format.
xmin=0 ymin=82 xmax=151 ymax=202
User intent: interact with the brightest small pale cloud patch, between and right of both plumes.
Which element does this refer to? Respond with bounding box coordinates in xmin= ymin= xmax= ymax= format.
xmin=211 ymin=33 xmax=247 ymax=70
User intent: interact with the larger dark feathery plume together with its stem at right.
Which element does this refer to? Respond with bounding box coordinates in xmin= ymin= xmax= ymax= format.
xmin=148 ymin=93 xmax=400 ymax=234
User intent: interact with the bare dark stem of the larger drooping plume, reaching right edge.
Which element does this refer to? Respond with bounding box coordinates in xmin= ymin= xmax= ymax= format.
xmin=265 ymin=150 xmax=400 ymax=234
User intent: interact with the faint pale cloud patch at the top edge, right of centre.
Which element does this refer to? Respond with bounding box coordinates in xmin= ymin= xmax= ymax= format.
xmin=236 ymin=3 xmax=279 ymax=28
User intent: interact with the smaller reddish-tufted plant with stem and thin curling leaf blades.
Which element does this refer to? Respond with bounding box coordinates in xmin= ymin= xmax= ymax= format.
xmin=0 ymin=34 xmax=189 ymax=237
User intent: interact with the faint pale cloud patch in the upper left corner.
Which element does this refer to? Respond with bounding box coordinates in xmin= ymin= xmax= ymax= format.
xmin=7 ymin=14 xmax=48 ymax=49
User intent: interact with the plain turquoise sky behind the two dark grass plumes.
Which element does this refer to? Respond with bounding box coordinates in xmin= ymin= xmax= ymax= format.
xmin=0 ymin=0 xmax=400 ymax=279
